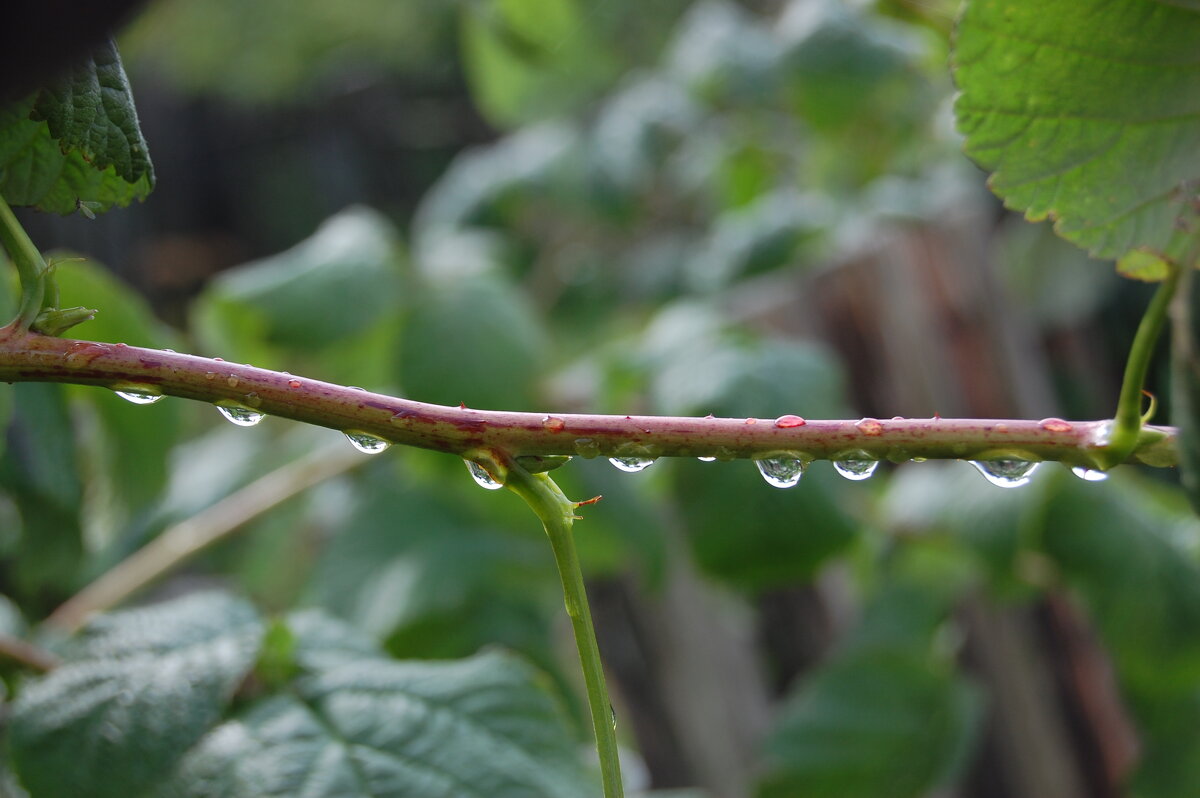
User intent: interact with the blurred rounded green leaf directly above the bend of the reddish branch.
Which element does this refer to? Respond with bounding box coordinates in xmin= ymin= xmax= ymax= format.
xmin=398 ymin=276 xmax=548 ymax=410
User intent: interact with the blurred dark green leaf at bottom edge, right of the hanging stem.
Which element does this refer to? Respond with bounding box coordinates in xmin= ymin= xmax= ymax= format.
xmin=757 ymin=584 xmax=979 ymax=798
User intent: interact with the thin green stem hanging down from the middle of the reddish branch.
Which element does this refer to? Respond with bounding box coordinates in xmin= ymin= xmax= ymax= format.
xmin=504 ymin=461 xmax=624 ymax=798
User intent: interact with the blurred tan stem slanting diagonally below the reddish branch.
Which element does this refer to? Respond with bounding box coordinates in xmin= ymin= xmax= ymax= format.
xmin=46 ymin=448 xmax=366 ymax=634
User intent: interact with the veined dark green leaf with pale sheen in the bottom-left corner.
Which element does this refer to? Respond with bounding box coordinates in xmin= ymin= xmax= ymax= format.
xmin=10 ymin=594 xmax=263 ymax=798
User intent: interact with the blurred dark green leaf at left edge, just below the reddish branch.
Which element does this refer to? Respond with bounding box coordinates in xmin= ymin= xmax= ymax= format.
xmin=0 ymin=383 xmax=83 ymax=598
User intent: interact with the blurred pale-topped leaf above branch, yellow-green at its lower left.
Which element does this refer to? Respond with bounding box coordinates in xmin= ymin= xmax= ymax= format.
xmin=197 ymin=208 xmax=406 ymax=358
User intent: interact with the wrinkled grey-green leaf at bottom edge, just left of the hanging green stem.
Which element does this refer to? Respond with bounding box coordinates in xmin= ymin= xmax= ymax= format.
xmin=161 ymin=653 xmax=596 ymax=798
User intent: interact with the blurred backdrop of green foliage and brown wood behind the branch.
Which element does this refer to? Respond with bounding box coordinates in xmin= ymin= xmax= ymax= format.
xmin=0 ymin=0 xmax=1200 ymax=798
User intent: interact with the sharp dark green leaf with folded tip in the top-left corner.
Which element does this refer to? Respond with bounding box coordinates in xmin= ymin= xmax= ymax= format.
xmin=0 ymin=41 xmax=155 ymax=214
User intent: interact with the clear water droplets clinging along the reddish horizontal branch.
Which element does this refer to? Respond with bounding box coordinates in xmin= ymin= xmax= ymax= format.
xmin=113 ymin=388 xmax=1108 ymax=491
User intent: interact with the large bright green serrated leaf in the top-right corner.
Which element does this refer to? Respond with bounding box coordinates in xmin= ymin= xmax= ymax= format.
xmin=953 ymin=0 xmax=1200 ymax=258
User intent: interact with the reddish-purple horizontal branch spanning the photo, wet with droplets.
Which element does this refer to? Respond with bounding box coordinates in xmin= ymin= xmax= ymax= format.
xmin=0 ymin=325 xmax=1177 ymax=468
